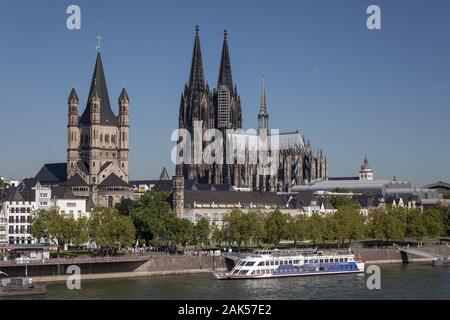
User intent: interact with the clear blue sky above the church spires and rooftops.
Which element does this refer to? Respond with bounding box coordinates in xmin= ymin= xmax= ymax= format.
xmin=0 ymin=0 xmax=450 ymax=185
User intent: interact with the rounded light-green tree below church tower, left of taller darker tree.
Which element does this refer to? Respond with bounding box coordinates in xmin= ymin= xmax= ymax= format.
xmin=89 ymin=207 xmax=136 ymax=250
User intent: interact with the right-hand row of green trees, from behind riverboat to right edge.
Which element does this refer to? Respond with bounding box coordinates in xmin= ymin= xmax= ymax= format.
xmin=212 ymin=204 xmax=446 ymax=247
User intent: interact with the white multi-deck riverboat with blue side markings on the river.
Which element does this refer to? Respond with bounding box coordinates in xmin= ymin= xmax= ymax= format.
xmin=214 ymin=249 xmax=364 ymax=280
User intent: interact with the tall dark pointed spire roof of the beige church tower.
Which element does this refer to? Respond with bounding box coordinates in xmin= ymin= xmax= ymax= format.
xmin=80 ymin=52 xmax=117 ymax=126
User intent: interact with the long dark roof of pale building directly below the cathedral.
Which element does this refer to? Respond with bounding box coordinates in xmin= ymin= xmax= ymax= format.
xmin=184 ymin=190 xmax=284 ymax=208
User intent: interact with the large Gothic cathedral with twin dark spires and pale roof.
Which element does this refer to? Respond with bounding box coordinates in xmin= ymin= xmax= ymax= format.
xmin=176 ymin=26 xmax=328 ymax=192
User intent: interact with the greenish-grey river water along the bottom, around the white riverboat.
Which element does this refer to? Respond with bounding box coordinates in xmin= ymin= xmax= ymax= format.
xmin=6 ymin=264 xmax=450 ymax=300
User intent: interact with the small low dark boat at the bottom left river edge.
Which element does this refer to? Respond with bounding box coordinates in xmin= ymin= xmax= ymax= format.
xmin=0 ymin=272 xmax=47 ymax=297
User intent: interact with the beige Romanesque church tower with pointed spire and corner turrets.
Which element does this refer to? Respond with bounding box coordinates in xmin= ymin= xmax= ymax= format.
xmin=67 ymin=49 xmax=130 ymax=206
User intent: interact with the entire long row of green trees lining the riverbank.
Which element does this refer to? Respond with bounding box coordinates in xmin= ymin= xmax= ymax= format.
xmin=31 ymin=192 xmax=450 ymax=254
